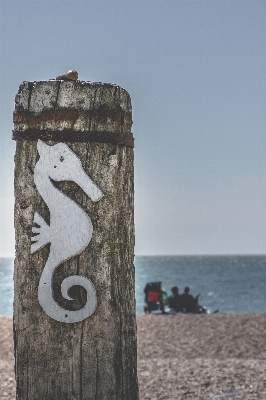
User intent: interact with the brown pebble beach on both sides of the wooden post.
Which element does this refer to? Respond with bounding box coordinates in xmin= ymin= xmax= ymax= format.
xmin=0 ymin=313 xmax=266 ymax=400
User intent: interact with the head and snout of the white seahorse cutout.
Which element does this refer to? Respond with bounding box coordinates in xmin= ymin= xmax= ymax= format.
xmin=37 ymin=139 xmax=103 ymax=201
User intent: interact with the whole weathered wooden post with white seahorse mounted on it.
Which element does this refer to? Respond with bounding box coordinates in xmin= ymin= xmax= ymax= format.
xmin=13 ymin=75 xmax=138 ymax=400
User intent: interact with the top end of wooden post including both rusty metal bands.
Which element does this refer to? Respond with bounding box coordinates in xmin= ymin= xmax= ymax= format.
xmin=13 ymin=71 xmax=134 ymax=147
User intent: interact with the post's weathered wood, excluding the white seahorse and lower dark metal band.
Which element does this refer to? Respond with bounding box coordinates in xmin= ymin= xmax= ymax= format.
xmin=14 ymin=81 xmax=138 ymax=400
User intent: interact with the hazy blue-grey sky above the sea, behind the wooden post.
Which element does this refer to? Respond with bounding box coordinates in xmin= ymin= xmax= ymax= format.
xmin=0 ymin=0 xmax=266 ymax=257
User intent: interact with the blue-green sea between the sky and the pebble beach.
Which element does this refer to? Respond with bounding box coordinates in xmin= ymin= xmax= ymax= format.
xmin=0 ymin=255 xmax=266 ymax=315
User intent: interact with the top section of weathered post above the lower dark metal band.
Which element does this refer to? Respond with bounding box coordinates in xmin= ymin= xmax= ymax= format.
xmin=14 ymin=80 xmax=132 ymax=135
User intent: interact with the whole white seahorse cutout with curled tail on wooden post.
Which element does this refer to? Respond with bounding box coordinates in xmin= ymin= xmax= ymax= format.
xmin=31 ymin=140 xmax=103 ymax=323
